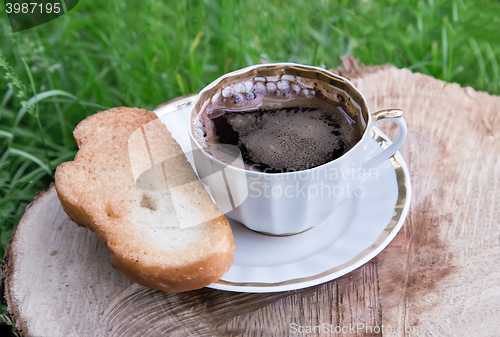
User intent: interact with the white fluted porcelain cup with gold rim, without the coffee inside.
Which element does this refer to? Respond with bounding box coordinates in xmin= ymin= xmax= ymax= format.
xmin=189 ymin=63 xmax=407 ymax=235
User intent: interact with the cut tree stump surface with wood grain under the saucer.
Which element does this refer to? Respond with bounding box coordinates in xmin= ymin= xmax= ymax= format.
xmin=2 ymin=58 xmax=500 ymax=337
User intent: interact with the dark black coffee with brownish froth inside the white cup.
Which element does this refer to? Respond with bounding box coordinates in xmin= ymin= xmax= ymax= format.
xmin=210 ymin=98 xmax=363 ymax=173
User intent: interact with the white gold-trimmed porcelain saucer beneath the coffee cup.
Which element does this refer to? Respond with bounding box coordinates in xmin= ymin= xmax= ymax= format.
xmin=155 ymin=96 xmax=411 ymax=293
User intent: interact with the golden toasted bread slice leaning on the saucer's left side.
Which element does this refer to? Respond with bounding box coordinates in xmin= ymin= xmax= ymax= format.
xmin=56 ymin=107 xmax=235 ymax=292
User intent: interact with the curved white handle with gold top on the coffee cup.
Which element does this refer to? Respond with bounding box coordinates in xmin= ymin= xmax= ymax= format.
xmin=363 ymin=109 xmax=408 ymax=169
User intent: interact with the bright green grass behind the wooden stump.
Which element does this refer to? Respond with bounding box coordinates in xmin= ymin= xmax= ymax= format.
xmin=0 ymin=0 xmax=500 ymax=268
